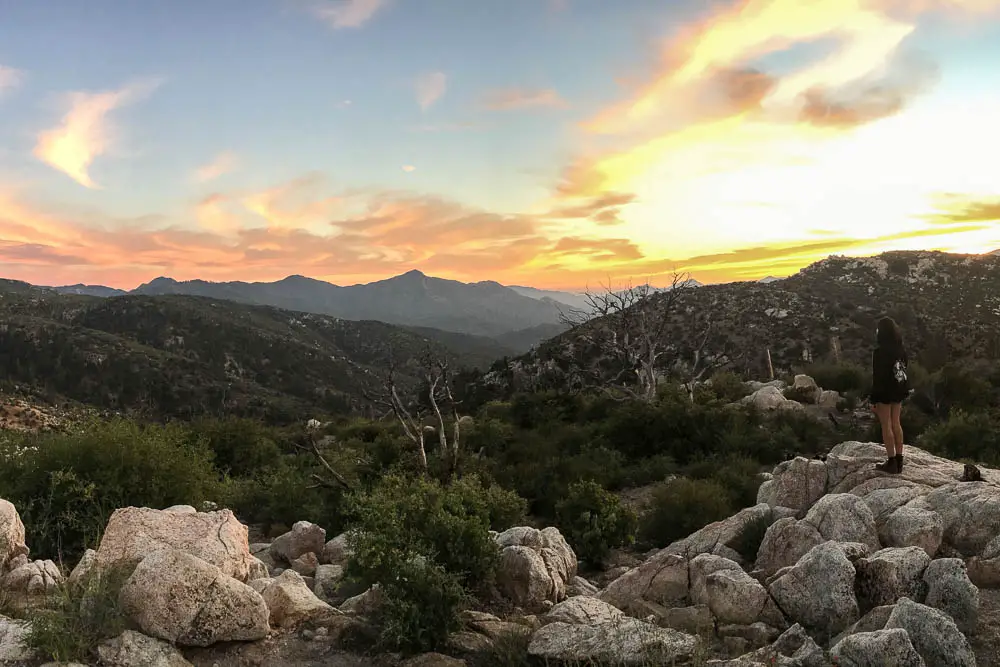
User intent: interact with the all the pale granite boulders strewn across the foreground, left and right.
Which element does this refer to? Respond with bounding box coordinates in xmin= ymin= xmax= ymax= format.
xmin=0 ymin=442 xmax=1000 ymax=667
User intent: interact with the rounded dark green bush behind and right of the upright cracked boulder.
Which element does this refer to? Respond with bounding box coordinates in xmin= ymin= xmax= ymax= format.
xmin=556 ymin=481 xmax=638 ymax=566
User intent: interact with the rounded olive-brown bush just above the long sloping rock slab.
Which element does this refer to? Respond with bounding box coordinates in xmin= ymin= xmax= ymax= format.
xmin=639 ymin=477 xmax=734 ymax=548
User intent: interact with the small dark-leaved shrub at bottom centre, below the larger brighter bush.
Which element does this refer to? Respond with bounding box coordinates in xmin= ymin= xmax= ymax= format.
xmin=373 ymin=559 xmax=467 ymax=653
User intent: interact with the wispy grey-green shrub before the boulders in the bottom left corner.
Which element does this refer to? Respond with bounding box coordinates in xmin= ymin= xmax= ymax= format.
xmin=26 ymin=571 xmax=128 ymax=663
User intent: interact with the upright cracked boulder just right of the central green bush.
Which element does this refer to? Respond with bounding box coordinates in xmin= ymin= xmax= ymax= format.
xmin=495 ymin=527 xmax=577 ymax=609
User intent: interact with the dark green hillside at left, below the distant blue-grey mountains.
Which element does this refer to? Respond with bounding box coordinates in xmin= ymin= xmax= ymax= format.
xmin=0 ymin=282 xmax=502 ymax=421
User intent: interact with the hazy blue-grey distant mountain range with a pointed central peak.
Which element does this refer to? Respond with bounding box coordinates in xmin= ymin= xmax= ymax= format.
xmin=45 ymin=271 xmax=585 ymax=351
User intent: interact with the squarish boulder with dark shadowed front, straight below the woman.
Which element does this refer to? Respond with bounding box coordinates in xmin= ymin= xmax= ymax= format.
xmin=854 ymin=547 xmax=931 ymax=609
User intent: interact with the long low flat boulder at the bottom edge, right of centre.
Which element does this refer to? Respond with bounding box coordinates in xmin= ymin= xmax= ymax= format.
xmin=528 ymin=618 xmax=698 ymax=667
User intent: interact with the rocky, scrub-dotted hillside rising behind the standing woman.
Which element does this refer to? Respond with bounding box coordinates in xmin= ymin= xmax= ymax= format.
xmin=491 ymin=252 xmax=1000 ymax=396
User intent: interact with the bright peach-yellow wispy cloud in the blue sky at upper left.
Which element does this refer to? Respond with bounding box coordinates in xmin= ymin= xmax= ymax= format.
xmin=34 ymin=80 xmax=159 ymax=188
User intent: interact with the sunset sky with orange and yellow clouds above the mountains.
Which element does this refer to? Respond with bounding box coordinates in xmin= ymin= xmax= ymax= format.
xmin=0 ymin=0 xmax=1000 ymax=289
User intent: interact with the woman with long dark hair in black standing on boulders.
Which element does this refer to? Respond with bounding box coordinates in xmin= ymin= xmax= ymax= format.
xmin=871 ymin=317 xmax=910 ymax=475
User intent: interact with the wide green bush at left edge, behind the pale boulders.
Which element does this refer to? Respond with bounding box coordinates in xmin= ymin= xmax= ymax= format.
xmin=0 ymin=419 xmax=224 ymax=561
